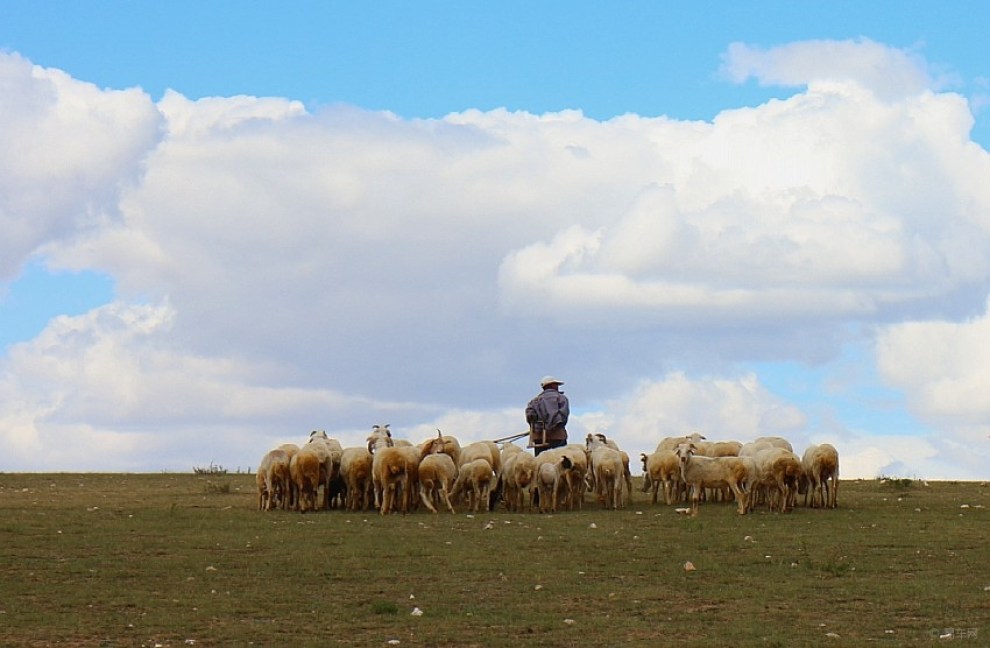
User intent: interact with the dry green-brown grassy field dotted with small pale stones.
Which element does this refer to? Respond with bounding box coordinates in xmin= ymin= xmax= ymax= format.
xmin=0 ymin=474 xmax=990 ymax=647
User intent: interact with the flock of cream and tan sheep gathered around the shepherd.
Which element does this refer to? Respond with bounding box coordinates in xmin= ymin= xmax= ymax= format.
xmin=257 ymin=425 xmax=839 ymax=515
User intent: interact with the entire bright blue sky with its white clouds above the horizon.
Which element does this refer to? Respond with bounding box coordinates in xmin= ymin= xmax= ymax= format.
xmin=0 ymin=0 xmax=990 ymax=479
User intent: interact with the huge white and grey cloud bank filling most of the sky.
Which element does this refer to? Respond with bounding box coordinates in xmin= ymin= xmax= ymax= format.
xmin=0 ymin=41 xmax=990 ymax=478
